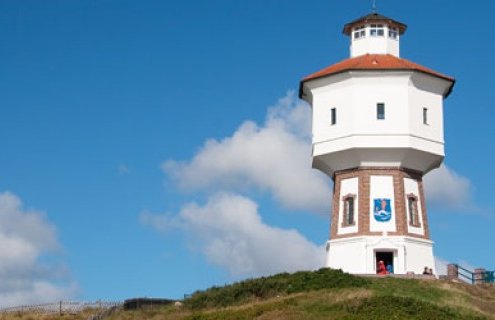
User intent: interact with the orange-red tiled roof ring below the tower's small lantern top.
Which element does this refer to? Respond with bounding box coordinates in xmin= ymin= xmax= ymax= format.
xmin=300 ymin=54 xmax=455 ymax=96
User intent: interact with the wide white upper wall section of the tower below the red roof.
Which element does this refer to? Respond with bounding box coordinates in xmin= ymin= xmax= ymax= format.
xmin=308 ymin=71 xmax=449 ymax=175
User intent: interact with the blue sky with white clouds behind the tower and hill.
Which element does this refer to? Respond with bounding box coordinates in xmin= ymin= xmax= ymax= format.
xmin=0 ymin=0 xmax=495 ymax=306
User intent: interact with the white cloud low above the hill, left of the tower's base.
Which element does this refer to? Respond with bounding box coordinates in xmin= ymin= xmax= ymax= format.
xmin=141 ymin=193 xmax=325 ymax=276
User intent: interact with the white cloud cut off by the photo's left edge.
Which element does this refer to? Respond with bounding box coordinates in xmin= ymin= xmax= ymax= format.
xmin=0 ymin=192 xmax=77 ymax=307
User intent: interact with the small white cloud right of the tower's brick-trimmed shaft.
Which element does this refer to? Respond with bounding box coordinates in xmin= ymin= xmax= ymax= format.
xmin=424 ymin=164 xmax=474 ymax=210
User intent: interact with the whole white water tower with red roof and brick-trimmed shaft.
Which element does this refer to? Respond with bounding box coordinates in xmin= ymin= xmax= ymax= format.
xmin=299 ymin=13 xmax=455 ymax=274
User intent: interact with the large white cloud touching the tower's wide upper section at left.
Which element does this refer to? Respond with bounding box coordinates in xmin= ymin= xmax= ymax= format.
xmin=162 ymin=93 xmax=331 ymax=213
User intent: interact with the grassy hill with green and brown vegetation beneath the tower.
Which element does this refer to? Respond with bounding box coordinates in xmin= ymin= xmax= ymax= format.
xmin=0 ymin=269 xmax=495 ymax=320
